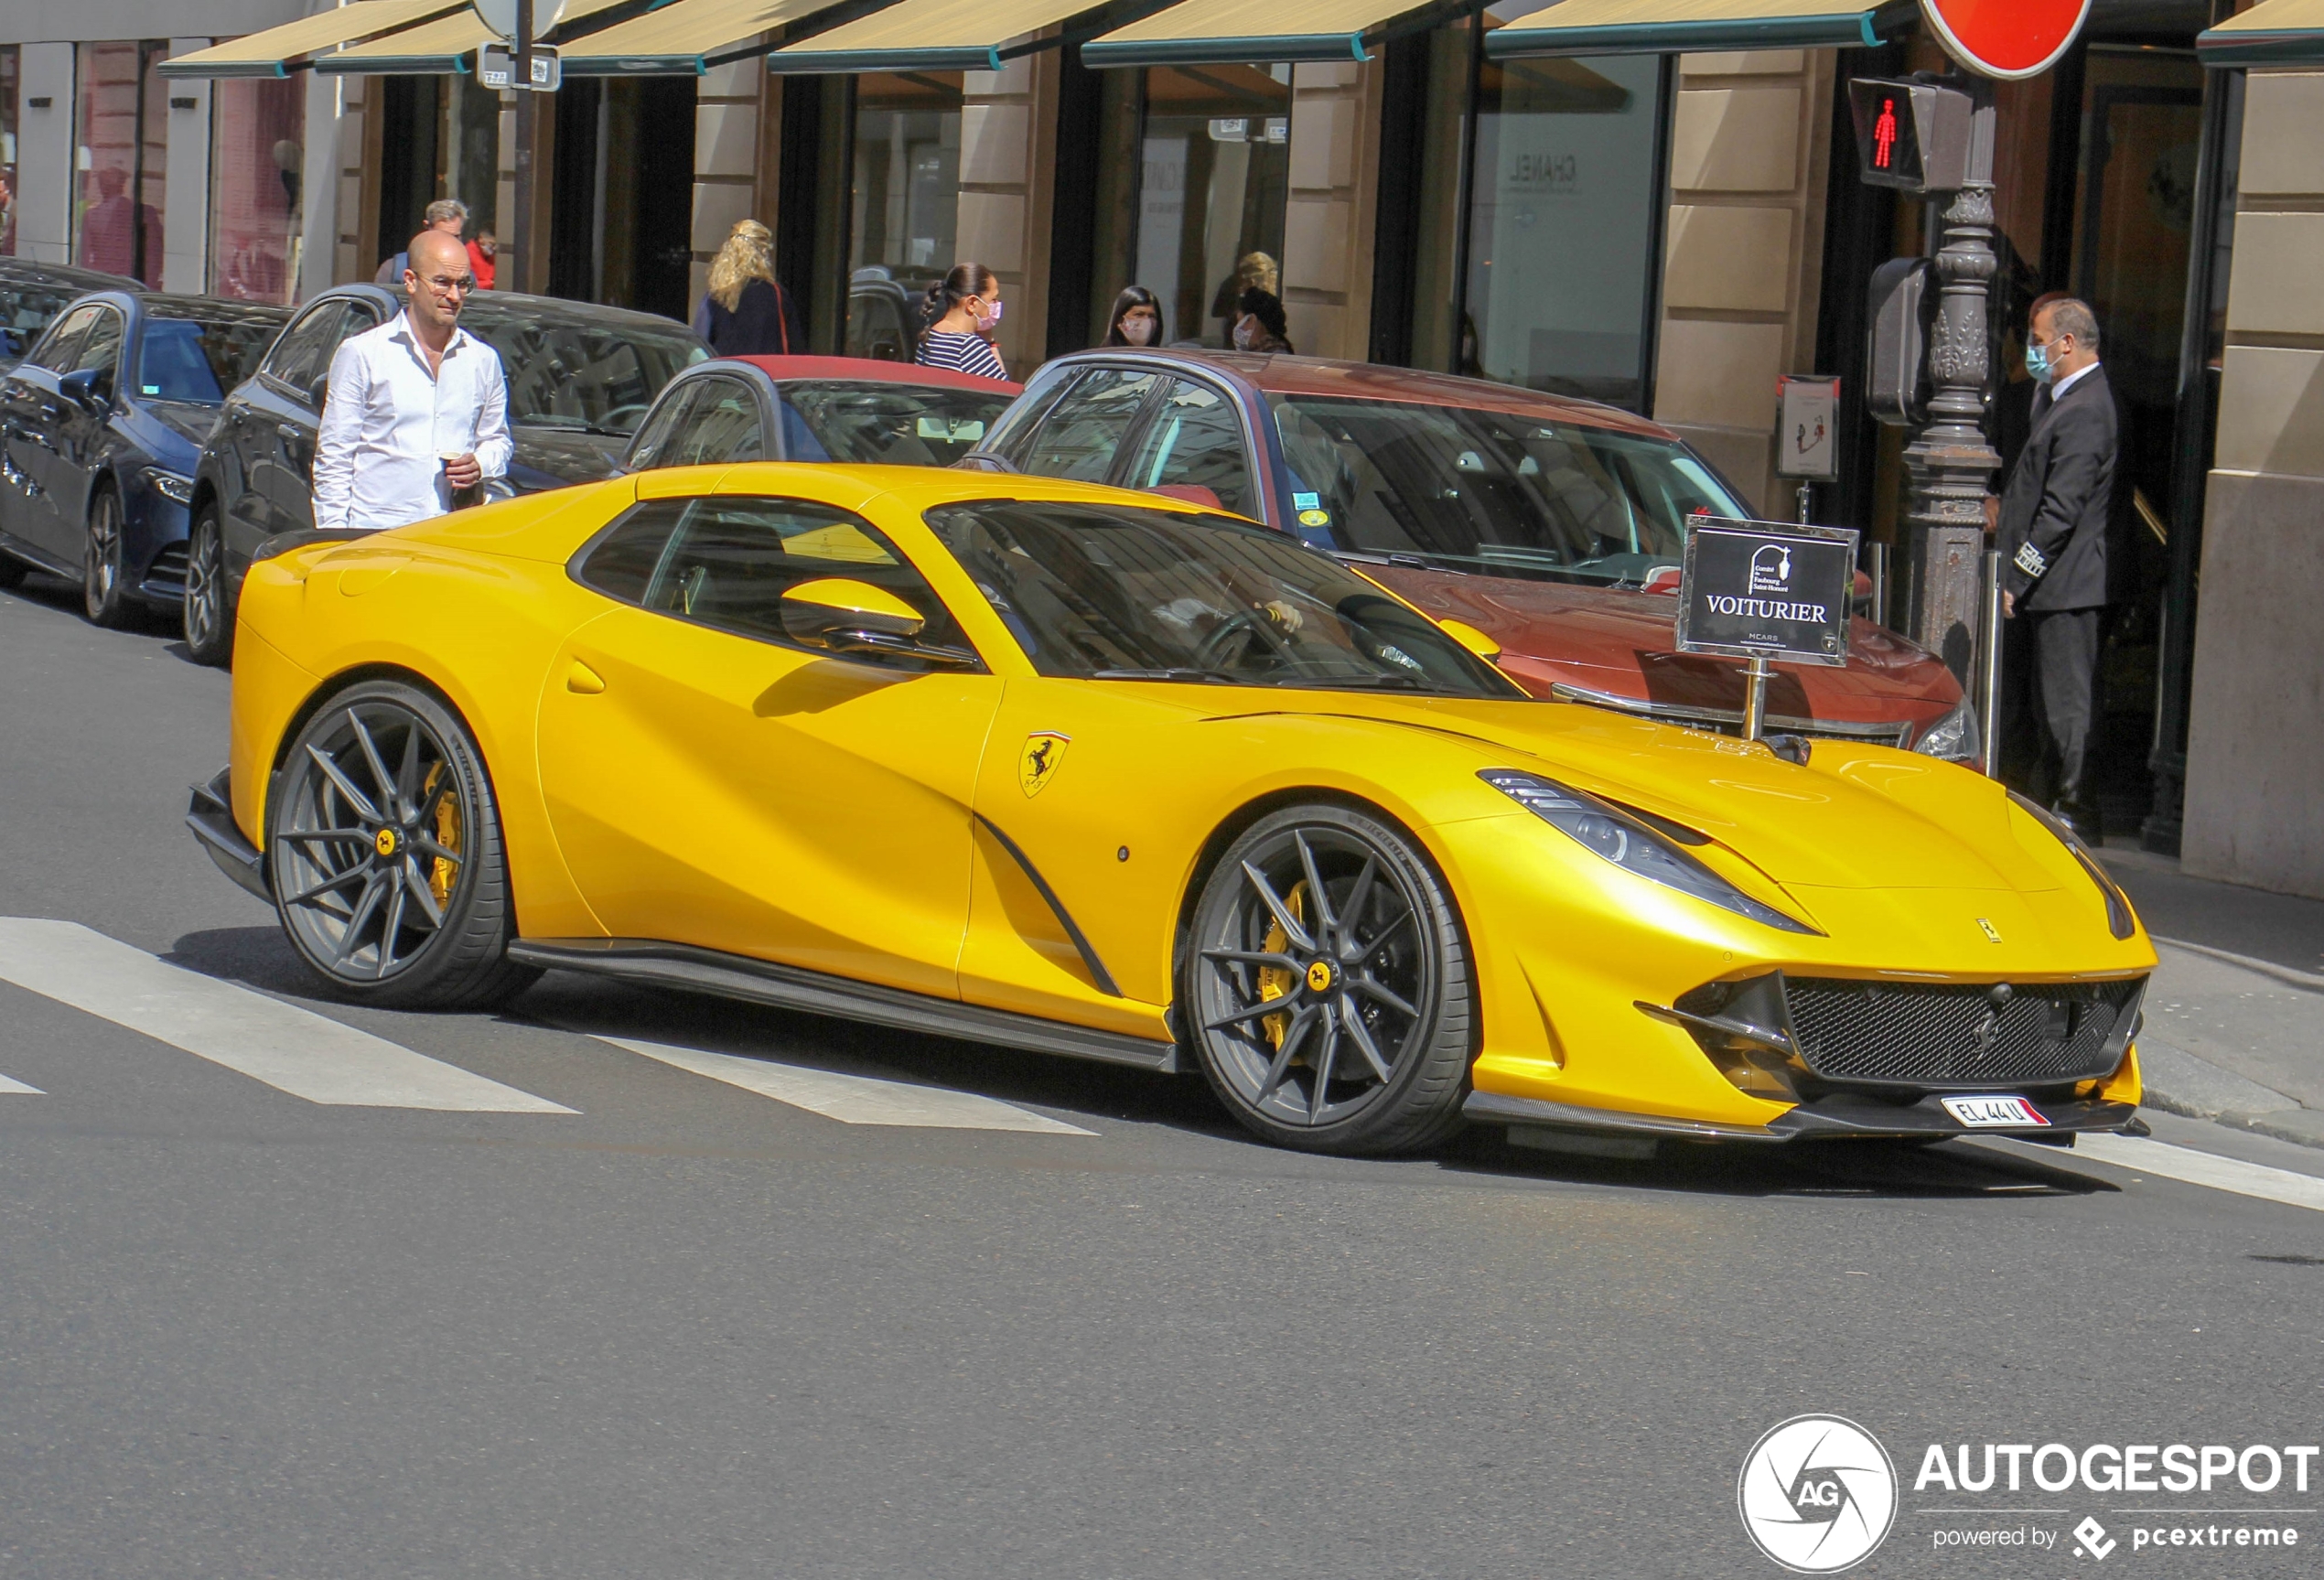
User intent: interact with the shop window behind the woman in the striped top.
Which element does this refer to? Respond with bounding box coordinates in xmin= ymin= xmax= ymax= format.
xmin=846 ymin=72 xmax=963 ymax=362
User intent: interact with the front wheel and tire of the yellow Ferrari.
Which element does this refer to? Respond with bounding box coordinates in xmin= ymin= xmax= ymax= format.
xmin=1178 ymin=804 xmax=1476 ymax=1153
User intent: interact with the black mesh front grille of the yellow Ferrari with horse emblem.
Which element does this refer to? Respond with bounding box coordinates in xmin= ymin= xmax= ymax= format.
xmin=1782 ymin=976 xmax=2145 ymax=1088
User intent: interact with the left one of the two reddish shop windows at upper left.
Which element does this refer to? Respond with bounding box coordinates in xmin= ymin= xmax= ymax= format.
xmin=72 ymin=39 xmax=169 ymax=288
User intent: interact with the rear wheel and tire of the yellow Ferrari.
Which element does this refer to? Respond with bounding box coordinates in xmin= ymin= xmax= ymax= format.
xmin=267 ymin=681 xmax=539 ymax=1011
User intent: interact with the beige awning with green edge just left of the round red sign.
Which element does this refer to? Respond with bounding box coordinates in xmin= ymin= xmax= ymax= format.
xmin=1485 ymin=0 xmax=1920 ymax=60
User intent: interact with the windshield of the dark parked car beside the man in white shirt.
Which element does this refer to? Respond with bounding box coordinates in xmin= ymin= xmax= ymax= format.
xmin=460 ymin=309 xmax=709 ymax=439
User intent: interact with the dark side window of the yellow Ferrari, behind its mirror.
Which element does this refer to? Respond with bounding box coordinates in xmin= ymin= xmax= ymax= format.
xmin=586 ymin=497 xmax=969 ymax=669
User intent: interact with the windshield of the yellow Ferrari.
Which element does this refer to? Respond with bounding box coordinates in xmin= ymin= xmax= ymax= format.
xmin=927 ymin=500 xmax=1518 ymax=697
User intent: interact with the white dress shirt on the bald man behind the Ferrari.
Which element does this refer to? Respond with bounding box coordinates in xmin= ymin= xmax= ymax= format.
xmin=314 ymin=314 xmax=516 ymax=532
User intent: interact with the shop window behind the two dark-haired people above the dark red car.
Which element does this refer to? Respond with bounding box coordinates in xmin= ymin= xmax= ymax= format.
xmin=1129 ymin=65 xmax=1292 ymax=346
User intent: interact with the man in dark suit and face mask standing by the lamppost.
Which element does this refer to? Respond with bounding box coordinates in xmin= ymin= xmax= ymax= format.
xmin=1996 ymin=297 xmax=2117 ymax=841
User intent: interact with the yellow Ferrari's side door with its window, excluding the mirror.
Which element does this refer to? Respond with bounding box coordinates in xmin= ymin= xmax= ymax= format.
xmin=539 ymin=492 xmax=1002 ymax=997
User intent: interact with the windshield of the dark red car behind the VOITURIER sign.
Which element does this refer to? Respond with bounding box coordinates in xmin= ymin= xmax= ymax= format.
xmin=1266 ymin=395 xmax=1757 ymax=586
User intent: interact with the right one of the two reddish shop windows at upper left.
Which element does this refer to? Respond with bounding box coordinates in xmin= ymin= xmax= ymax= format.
xmin=210 ymin=77 xmax=307 ymax=306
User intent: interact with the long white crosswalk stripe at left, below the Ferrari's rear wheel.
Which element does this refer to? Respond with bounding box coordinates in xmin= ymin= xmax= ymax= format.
xmin=0 ymin=916 xmax=572 ymax=1113
